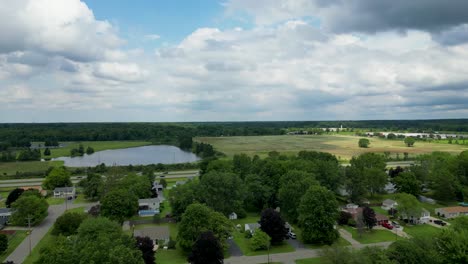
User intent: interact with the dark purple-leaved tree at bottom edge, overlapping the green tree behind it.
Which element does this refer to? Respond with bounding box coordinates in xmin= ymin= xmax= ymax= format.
xmin=188 ymin=231 xmax=224 ymax=264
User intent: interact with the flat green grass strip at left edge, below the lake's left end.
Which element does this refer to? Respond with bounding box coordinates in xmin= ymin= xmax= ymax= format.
xmin=0 ymin=161 xmax=63 ymax=175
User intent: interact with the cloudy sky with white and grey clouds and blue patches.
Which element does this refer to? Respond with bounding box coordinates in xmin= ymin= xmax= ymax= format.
xmin=0 ymin=0 xmax=468 ymax=122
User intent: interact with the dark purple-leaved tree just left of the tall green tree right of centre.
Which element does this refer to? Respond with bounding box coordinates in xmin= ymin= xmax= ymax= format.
xmin=260 ymin=208 xmax=288 ymax=244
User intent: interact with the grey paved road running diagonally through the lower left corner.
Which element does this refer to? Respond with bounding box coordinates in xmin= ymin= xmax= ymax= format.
xmin=6 ymin=202 xmax=91 ymax=263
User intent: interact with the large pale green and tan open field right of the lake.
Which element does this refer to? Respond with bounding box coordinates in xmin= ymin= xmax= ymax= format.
xmin=195 ymin=135 xmax=468 ymax=160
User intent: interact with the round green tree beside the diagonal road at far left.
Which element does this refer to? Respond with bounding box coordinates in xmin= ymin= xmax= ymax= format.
xmin=10 ymin=195 xmax=49 ymax=226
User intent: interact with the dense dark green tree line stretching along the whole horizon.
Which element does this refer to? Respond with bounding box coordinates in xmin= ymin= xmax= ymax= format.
xmin=0 ymin=119 xmax=468 ymax=146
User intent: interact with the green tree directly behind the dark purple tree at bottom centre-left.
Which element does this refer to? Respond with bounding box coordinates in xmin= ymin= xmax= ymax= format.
xmin=177 ymin=204 xmax=233 ymax=251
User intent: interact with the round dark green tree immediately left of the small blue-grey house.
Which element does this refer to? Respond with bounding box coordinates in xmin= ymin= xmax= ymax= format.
xmin=101 ymin=189 xmax=138 ymax=223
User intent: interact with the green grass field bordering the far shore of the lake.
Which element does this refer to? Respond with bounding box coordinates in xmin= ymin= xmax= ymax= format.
xmin=34 ymin=141 xmax=151 ymax=158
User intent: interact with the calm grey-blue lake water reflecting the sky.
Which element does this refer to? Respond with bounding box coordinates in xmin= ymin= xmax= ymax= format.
xmin=52 ymin=145 xmax=199 ymax=167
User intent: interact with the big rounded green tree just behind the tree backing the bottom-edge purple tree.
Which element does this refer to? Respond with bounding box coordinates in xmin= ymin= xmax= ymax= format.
xmin=199 ymin=171 xmax=246 ymax=215
